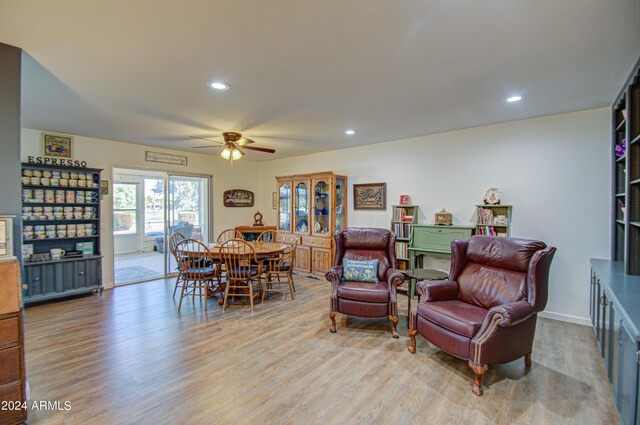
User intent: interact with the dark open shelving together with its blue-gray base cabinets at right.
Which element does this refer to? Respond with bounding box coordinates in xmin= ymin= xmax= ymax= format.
xmin=590 ymin=56 xmax=640 ymax=425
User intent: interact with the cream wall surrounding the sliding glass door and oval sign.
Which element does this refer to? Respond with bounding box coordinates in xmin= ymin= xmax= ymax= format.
xmin=21 ymin=129 xmax=260 ymax=288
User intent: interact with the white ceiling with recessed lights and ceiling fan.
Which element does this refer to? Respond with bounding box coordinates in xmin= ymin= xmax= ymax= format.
xmin=0 ymin=0 xmax=640 ymax=161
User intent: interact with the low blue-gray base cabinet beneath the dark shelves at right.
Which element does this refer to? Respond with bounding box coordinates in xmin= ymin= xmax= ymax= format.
xmin=589 ymin=259 xmax=640 ymax=425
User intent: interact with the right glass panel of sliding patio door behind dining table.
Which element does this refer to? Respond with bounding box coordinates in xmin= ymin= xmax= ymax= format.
xmin=165 ymin=174 xmax=211 ymax=273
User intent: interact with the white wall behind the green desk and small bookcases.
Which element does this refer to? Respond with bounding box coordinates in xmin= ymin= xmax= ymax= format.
xmin=259 ymin=108 xmax=611 ymax=324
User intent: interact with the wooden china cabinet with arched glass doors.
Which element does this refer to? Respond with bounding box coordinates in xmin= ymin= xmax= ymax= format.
xmin=276 ymin=171 xmax=347 ymax=276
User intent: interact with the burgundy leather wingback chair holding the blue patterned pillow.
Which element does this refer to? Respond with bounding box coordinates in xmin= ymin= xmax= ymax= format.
xmin=325 ymin=227 xmax=404 ymax=338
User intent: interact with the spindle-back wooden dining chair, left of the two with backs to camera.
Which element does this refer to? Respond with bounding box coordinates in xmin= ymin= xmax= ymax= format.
xmin=176 ymin=239 xmax=224 ymax=312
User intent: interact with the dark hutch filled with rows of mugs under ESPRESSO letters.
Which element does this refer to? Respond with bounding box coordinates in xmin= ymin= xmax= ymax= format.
xmin=22 ymin=164 xmax=102 ymax=304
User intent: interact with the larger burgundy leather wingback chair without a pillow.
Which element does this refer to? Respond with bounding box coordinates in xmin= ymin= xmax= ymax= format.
xmin=409 ymin=236 xmax=556 ymax=395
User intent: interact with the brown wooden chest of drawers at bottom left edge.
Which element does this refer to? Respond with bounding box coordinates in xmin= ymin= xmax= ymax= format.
xmin=0 ymin=260 xmax=27 ymax=425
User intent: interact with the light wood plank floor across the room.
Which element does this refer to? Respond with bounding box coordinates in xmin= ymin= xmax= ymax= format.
xmin=25 ymin=276 xmax=619 ymax=425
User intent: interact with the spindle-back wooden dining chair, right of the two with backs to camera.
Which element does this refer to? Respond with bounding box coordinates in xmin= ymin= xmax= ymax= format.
xmin=219 ymin=239 xmax=264 ymax=311
